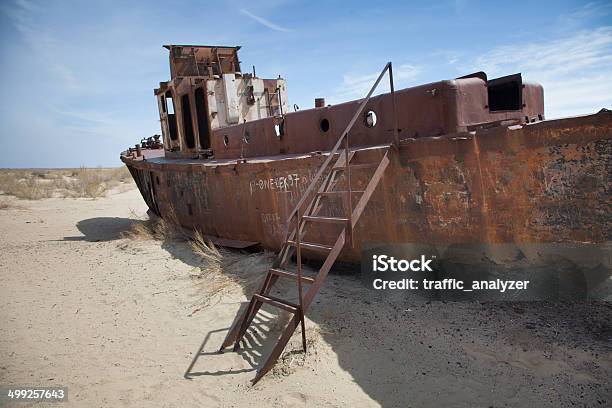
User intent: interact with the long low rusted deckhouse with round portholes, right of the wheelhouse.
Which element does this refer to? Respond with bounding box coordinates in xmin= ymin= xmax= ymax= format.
xmin=212 ymin=78 xmax=544 ymax=158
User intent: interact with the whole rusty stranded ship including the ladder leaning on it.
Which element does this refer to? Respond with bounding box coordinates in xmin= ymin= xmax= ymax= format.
xmin=121 ymin=45 xmax=612 ymax=381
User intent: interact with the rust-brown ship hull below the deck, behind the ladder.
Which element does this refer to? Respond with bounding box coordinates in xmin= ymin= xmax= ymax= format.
xmin=122 ymin=113 xmax=612 ymax=270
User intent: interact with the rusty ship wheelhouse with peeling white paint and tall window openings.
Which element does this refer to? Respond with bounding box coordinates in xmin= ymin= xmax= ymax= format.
xmin=154 ymin=45 xmax=287 ymax=158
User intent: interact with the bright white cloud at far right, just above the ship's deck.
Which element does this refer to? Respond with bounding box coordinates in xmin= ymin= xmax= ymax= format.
xmin=464 ymin=27 xmax=612 ymax=118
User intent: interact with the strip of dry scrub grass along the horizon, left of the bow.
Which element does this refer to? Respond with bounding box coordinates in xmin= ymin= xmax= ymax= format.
xmin=0 ymin=166 xmax=133 ymax=200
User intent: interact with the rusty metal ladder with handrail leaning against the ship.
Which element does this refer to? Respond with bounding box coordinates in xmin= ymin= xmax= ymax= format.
xmin=219 ymin=62 xmax=398 ymax=384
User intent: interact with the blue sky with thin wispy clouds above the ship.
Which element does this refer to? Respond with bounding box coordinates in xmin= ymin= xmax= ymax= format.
xmin=0 ymin=0 xmax=612 ymax=167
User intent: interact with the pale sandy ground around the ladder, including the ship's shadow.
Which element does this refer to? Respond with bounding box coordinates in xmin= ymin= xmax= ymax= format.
xmin=0 ymin=186 xmax=612 ymax=407
